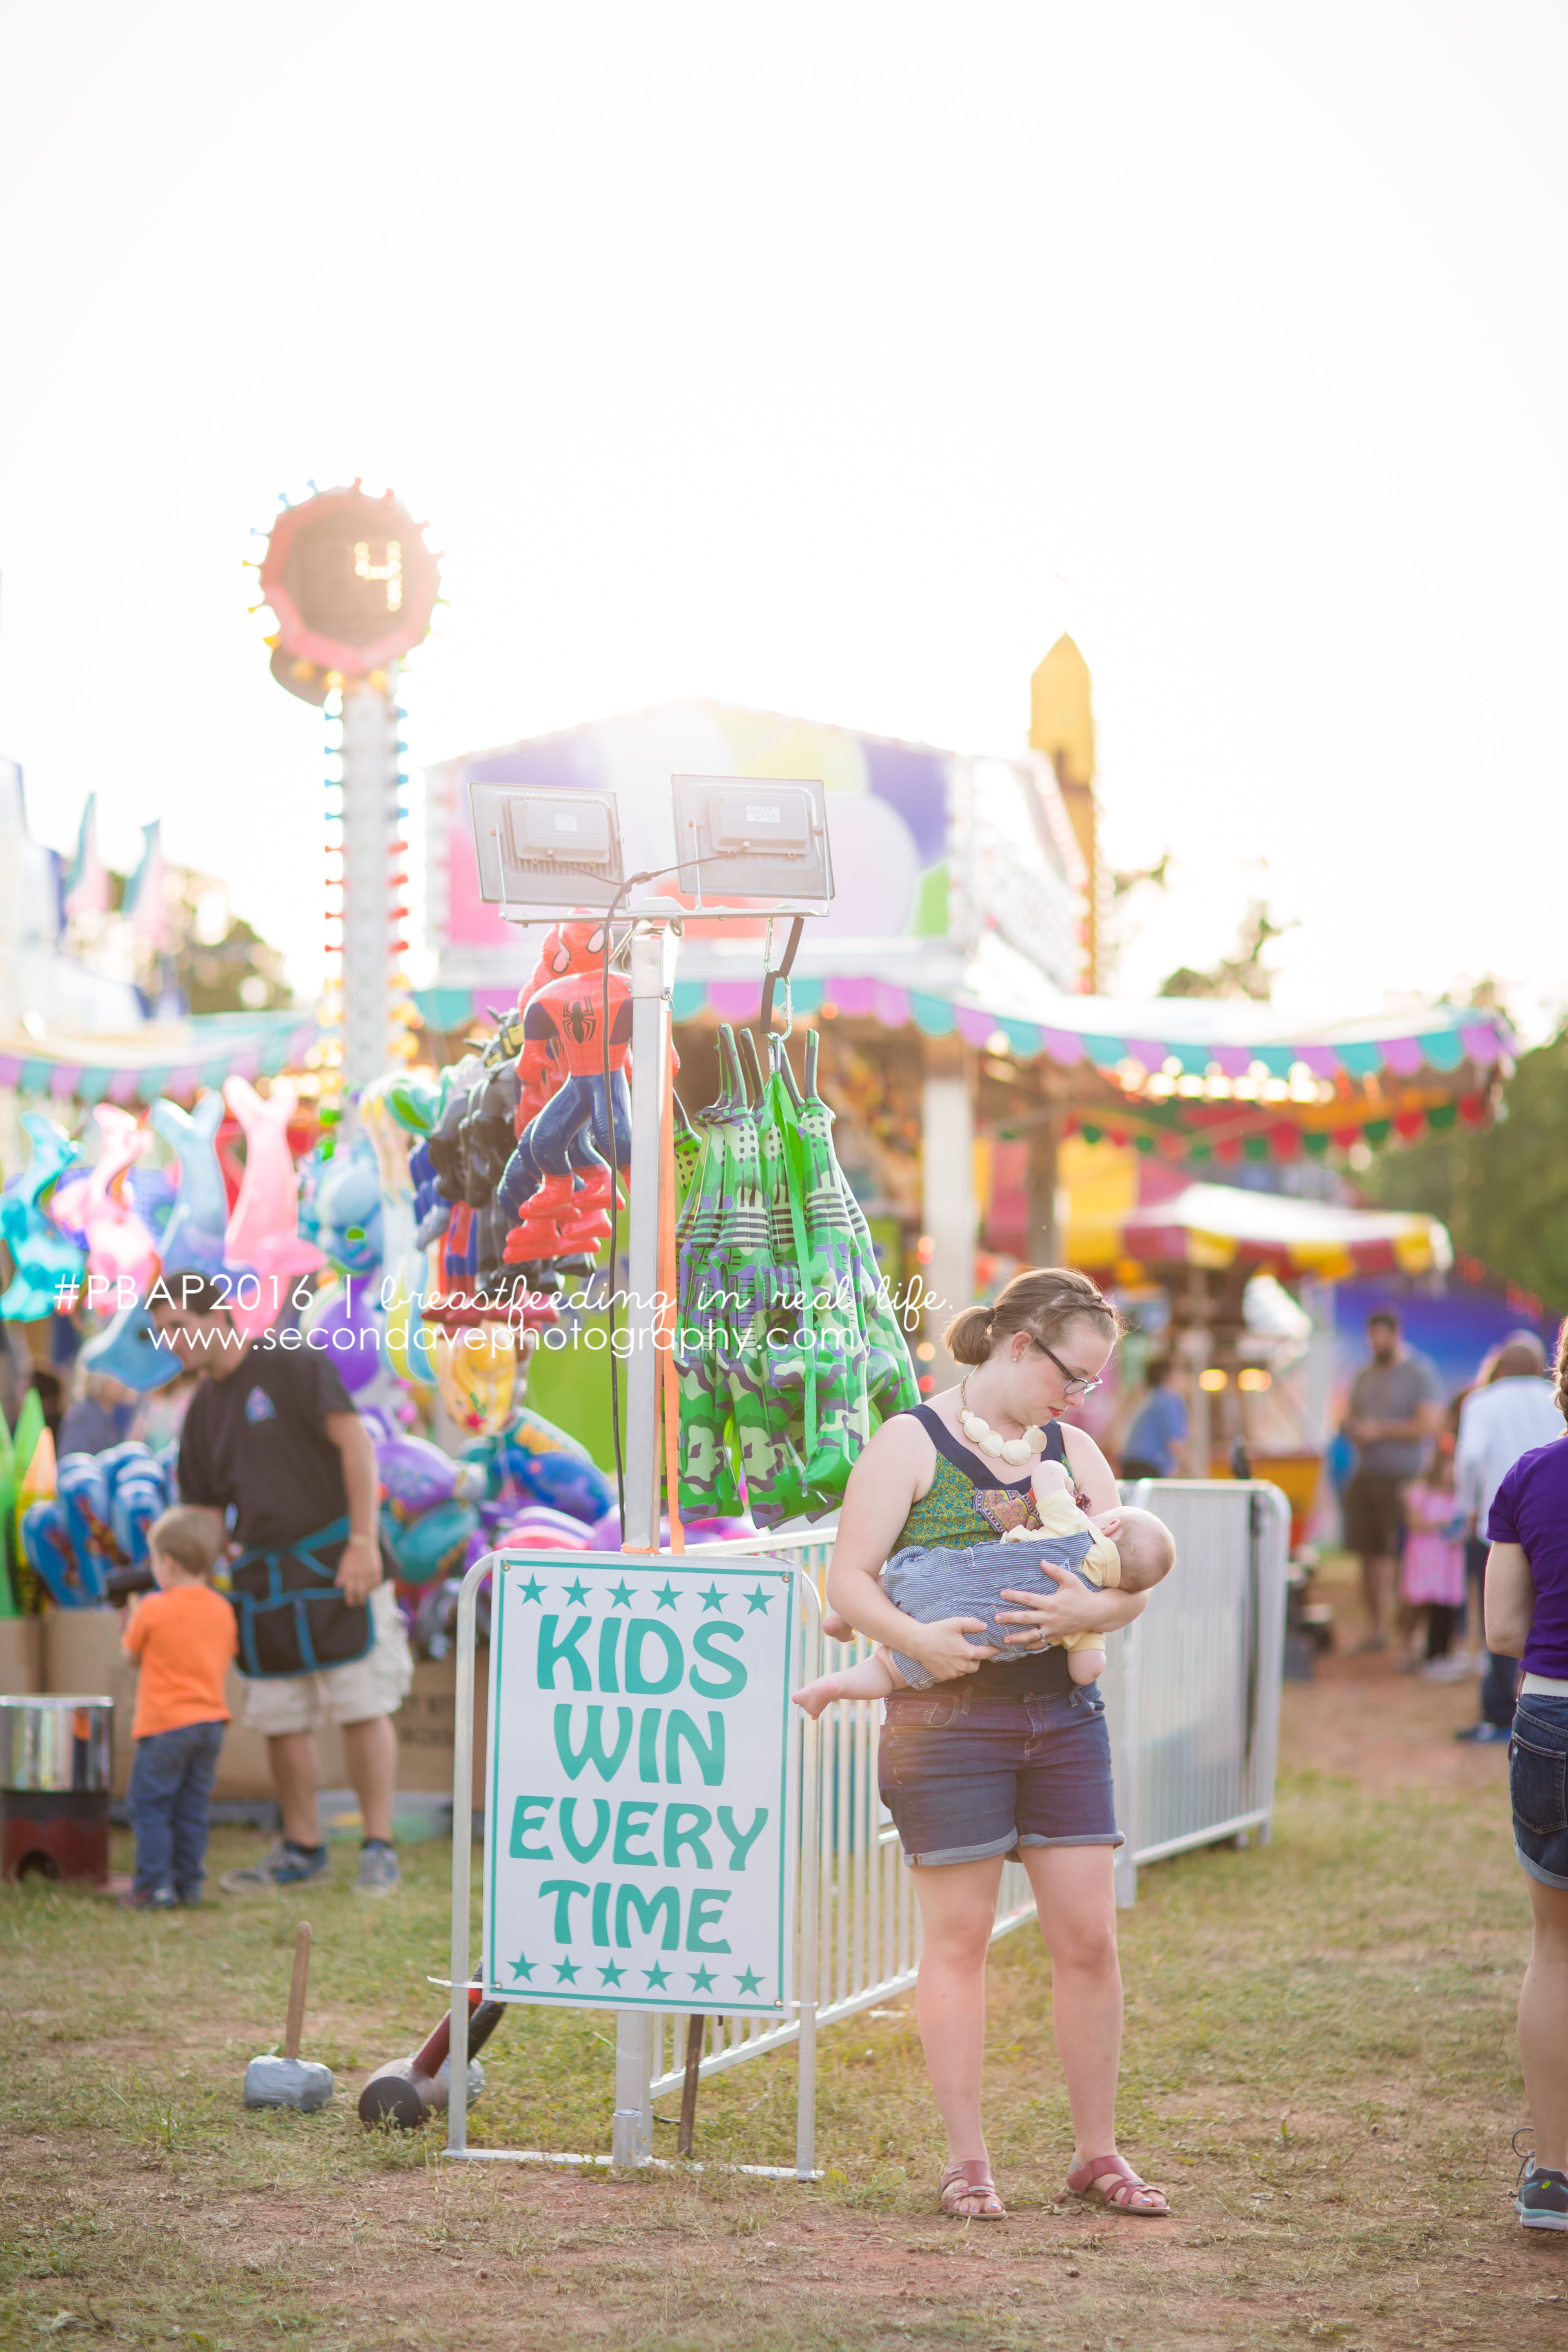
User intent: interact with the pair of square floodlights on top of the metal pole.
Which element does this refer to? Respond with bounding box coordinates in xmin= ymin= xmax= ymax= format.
xmin=468 ymin=776 xmax=832 ymax=922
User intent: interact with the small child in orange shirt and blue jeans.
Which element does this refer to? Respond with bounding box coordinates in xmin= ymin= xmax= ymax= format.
xmin=120 ymin=1510 xmax=240 ymax=1910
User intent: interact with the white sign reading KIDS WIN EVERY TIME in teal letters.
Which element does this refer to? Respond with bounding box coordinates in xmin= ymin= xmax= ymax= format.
xmin=484 ymin=1550 xmax=799 ymax=2018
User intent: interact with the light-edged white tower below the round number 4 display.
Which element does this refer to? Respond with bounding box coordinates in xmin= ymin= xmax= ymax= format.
xmin=341 ymin=680 xmax=400 ymax=1105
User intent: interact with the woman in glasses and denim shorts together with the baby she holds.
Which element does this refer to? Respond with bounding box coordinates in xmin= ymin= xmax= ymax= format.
xmin=818 ymin=1268 xmax=1173 ymax=2220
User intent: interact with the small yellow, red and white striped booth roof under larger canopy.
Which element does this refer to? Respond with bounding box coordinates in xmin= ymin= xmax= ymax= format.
xmin=1069 ymin=1183 xmax=1453 ymax=1282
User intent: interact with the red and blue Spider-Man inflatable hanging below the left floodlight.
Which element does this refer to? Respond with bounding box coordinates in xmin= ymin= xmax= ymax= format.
xmin=496 ymin=922 xmax=633 ymax=1265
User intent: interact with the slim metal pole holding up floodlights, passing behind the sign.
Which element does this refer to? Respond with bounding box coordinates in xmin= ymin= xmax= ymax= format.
xmin=611 ymin=924 xmax=675 ymax=2164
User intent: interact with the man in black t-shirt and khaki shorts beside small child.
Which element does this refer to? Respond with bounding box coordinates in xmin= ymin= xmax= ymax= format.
xmin=148 ymin=1275 xmax=414 ymax=1893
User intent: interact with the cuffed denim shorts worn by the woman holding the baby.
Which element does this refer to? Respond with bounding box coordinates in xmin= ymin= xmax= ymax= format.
xmin=877 ymin=1679 xmax=1121 ymax=1863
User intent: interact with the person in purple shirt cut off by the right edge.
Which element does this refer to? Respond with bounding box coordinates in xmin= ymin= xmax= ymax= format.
xmin=1486 ymin=1322 xmax=1568 ymax=2230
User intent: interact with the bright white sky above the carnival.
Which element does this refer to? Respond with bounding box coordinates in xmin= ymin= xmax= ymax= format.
xmin=0 ymin=0 xmax=1568 ymax=1025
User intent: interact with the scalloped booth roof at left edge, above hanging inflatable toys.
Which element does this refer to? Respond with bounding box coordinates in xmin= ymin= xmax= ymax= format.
xmin=0 ymin=1011 xmax=317 ymax=1103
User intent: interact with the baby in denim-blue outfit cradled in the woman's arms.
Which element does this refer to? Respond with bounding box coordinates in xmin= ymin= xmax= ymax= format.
xmin=792 ymin=1461 xmax=1176 ymax=1717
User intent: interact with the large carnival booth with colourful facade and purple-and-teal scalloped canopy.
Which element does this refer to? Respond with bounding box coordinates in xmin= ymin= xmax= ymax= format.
xmin=419 ymin=696 xmax=1512 ymax=1388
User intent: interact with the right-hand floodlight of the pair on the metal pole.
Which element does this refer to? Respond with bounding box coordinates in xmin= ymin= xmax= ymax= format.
xmin=670 ymin=776 xmax=832 ymax=913
